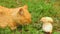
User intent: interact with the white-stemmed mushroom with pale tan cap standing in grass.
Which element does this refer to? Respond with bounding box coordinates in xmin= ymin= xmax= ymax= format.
xmin=40 ymin=17 xmax=53 ymax=34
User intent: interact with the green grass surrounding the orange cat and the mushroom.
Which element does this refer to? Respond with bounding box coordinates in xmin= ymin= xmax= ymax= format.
xmin=0 ymin=0 xmax=60 ymax=34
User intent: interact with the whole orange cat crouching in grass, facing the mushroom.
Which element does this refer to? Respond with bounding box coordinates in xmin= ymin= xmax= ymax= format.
xmin=0 ymin=5 xmax=31 ymax=30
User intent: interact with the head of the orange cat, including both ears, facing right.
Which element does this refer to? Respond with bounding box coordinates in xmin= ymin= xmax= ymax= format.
xmin=14 ymin=5 xmax=31 ymax=25
